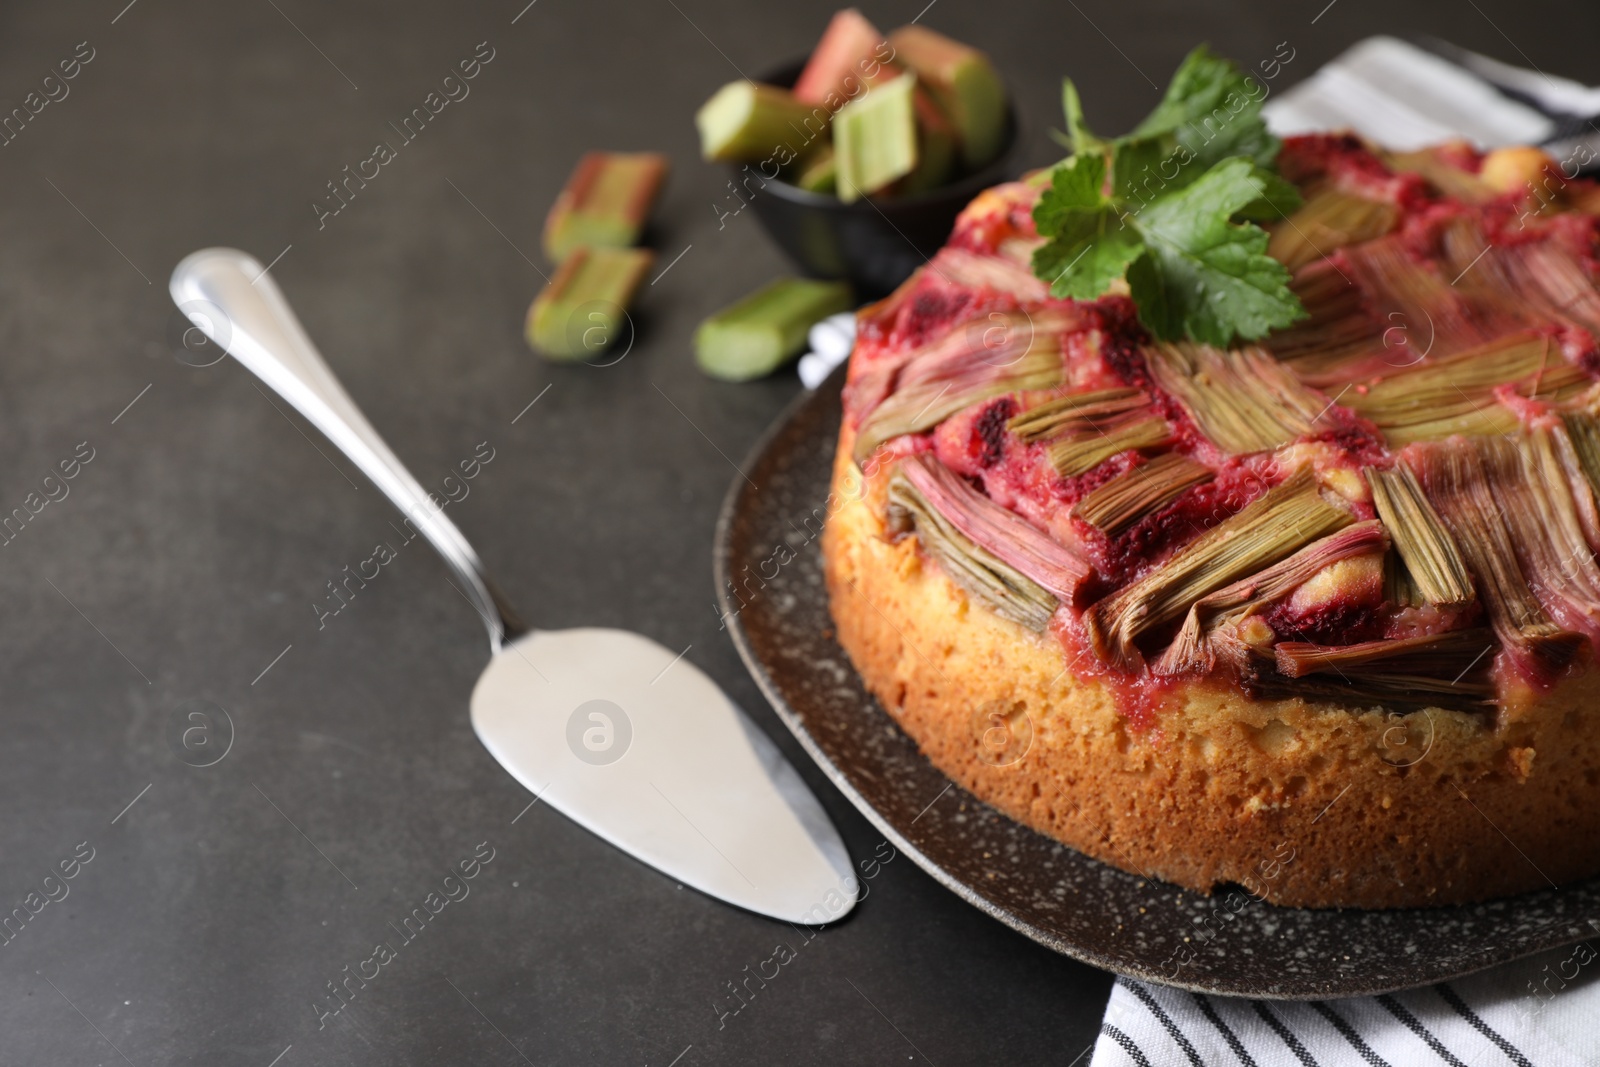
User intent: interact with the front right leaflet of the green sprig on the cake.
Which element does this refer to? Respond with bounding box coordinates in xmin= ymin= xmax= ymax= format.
xmin=1128 ymin=158 xmax=1306 ymax=346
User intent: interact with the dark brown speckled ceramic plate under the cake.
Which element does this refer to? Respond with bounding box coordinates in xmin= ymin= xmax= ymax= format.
xmin=715 ymin=371 xmax=1600 ymax=1000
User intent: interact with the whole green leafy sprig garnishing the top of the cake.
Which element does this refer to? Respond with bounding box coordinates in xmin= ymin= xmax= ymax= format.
xmin=1034 ymin=45 xmax=1306 ymax=346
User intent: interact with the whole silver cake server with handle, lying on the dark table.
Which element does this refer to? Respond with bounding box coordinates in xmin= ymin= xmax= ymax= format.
xmin=170 ymin=248 xmax=856 ymax=923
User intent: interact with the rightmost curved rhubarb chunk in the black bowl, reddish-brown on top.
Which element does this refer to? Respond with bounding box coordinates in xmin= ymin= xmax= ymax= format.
xmin=890 ymin=24 xmax=1006 ymax=170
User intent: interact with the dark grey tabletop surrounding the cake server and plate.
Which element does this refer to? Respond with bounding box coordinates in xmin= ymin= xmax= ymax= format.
xmin=0 ymin=0 xmax=1600 ymax=1067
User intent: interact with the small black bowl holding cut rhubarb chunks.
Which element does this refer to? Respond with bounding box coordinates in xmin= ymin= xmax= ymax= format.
xmin=734 ymin=61 xmax=1021 ymax=299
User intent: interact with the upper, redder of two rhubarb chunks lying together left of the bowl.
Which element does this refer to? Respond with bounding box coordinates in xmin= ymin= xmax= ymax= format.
xmin=544 ymin=152 xmax=667 ymax=262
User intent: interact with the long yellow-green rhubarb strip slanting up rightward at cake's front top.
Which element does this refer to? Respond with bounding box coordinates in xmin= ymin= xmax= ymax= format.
xmin=1083 ymin=467 xmax=1355 ymax=669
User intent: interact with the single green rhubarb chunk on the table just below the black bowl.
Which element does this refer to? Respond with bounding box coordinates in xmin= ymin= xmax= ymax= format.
xmin=694 ymin=278 xmax=851 ymax=382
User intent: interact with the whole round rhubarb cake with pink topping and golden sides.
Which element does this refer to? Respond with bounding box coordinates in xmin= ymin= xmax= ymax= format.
xmin=824 ymin=136 xmax=1600 ymax=907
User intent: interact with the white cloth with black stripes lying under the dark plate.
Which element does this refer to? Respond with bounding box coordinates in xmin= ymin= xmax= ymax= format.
xmin=1090 ymin=37 xmax=1600 ymax=1067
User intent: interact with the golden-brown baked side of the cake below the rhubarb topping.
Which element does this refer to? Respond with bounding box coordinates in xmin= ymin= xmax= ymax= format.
xmin=822 ymin=424 xmax=1600 ymax=907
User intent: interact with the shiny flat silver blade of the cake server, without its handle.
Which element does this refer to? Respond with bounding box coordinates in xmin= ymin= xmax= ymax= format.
xmin=472 ymin=629 xmax=856 ymax=923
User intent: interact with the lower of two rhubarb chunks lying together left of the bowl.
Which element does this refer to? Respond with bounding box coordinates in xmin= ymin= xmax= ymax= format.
xmin=526 ymin=246 xmax=654 ymax=360
